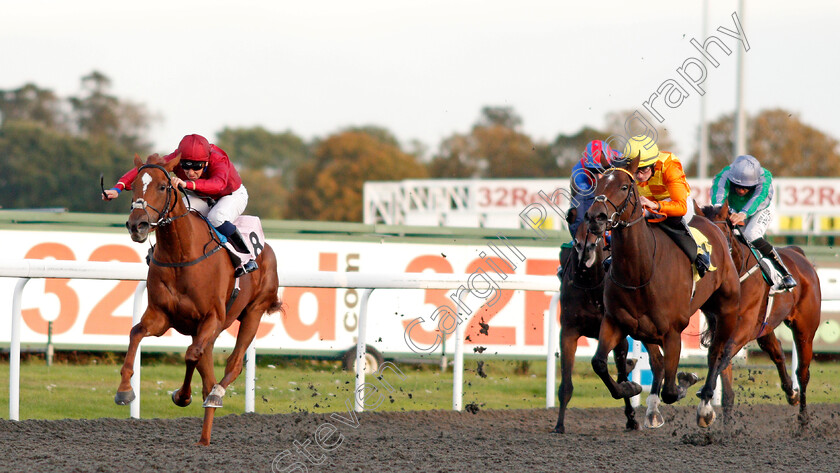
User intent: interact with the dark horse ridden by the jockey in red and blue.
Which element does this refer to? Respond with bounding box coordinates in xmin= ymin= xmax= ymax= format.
xmin=552 ymin=221 xmax=639 ymax=434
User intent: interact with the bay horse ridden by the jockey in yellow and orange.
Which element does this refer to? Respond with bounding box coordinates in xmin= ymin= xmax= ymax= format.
xmin=585 ymin=158 xmax=740 ymax=427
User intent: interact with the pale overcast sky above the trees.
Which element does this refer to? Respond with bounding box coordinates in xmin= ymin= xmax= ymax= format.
xmin=0 ymin=0 xmax=840 ymax=168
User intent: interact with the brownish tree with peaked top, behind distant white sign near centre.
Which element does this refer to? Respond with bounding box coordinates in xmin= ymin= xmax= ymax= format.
xmin=429 ymin=107 xmax=541 ymax=178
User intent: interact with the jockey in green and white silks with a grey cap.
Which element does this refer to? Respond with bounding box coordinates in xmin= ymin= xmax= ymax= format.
xmin=712 ymin=155 xmax=796 ymax=289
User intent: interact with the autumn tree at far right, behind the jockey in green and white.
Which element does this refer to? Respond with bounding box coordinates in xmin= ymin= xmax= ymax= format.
xmin=688 ymin=109 xmax=840 ymax=177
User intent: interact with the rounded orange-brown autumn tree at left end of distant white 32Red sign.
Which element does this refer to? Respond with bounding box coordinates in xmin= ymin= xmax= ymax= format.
xmin=289 ymin=131 xmax=434 ymax=222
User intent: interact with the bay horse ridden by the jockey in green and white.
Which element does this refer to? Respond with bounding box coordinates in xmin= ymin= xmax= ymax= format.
xmin=702 ymin=203 xmax=822 ymax=425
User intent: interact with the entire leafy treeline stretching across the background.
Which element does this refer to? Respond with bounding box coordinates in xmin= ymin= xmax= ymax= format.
xmin=0 ymin=71 xmax=840 ymax=221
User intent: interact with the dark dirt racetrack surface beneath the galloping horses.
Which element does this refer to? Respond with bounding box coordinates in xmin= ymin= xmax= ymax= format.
xmin=0 ymin=404 xmax=840 ymax=473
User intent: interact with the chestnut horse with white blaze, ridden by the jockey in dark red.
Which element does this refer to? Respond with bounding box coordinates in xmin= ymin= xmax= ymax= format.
xmin=114 ymin=154 xmax=282 ymax=445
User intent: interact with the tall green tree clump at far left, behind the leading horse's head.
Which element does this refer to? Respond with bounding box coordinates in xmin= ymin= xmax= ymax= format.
xmin=0 ymin=73 xmax=150 ymax=212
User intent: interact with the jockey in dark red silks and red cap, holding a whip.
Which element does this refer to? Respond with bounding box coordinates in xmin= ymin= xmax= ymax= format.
xmin=102 ymin=135 xmax=258 ymax=276
